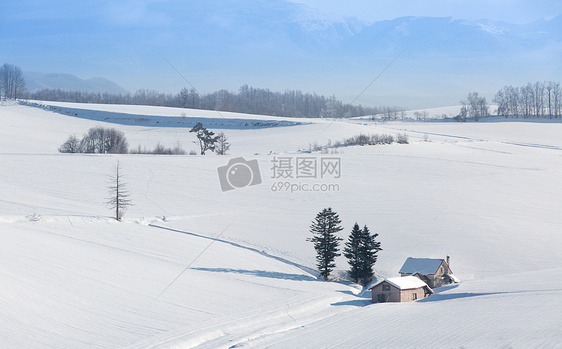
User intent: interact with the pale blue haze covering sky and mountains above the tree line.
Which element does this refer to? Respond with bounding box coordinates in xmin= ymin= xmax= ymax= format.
xmin=0 ymin=0 xmax=562 ymax=108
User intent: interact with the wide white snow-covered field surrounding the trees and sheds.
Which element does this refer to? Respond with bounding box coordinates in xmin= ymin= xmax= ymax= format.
xmin=0 ymin=102 xmax=562 ymax=348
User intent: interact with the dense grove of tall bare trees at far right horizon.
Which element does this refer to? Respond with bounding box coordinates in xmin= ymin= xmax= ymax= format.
xmin=494 ymin=81 xmax=562 ymax=118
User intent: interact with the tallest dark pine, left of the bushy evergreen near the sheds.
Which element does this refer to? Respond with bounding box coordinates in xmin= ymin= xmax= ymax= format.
xmin=307 ymin=208 xmax=343 ymax=280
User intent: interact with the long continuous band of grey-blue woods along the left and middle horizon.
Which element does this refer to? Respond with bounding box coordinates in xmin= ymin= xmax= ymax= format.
xmin=29 ymin=85 xmax=384 ymax=118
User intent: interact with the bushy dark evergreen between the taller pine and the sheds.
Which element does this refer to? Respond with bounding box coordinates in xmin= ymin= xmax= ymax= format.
xmin=344 ymin=223 xmax=382 ymax=285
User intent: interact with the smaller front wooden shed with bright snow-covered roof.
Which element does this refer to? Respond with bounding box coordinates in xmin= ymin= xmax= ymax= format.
xmin=369 ymin=276 xmax=433 ymax=303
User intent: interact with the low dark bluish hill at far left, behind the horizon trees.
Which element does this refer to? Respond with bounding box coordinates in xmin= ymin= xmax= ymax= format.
xmin=23 ymin=72 xmax=128 ymax=94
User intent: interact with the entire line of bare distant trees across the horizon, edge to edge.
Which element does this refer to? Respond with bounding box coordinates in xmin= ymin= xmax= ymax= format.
xmin=4 ymin=63 xmax=562 ymax=121
